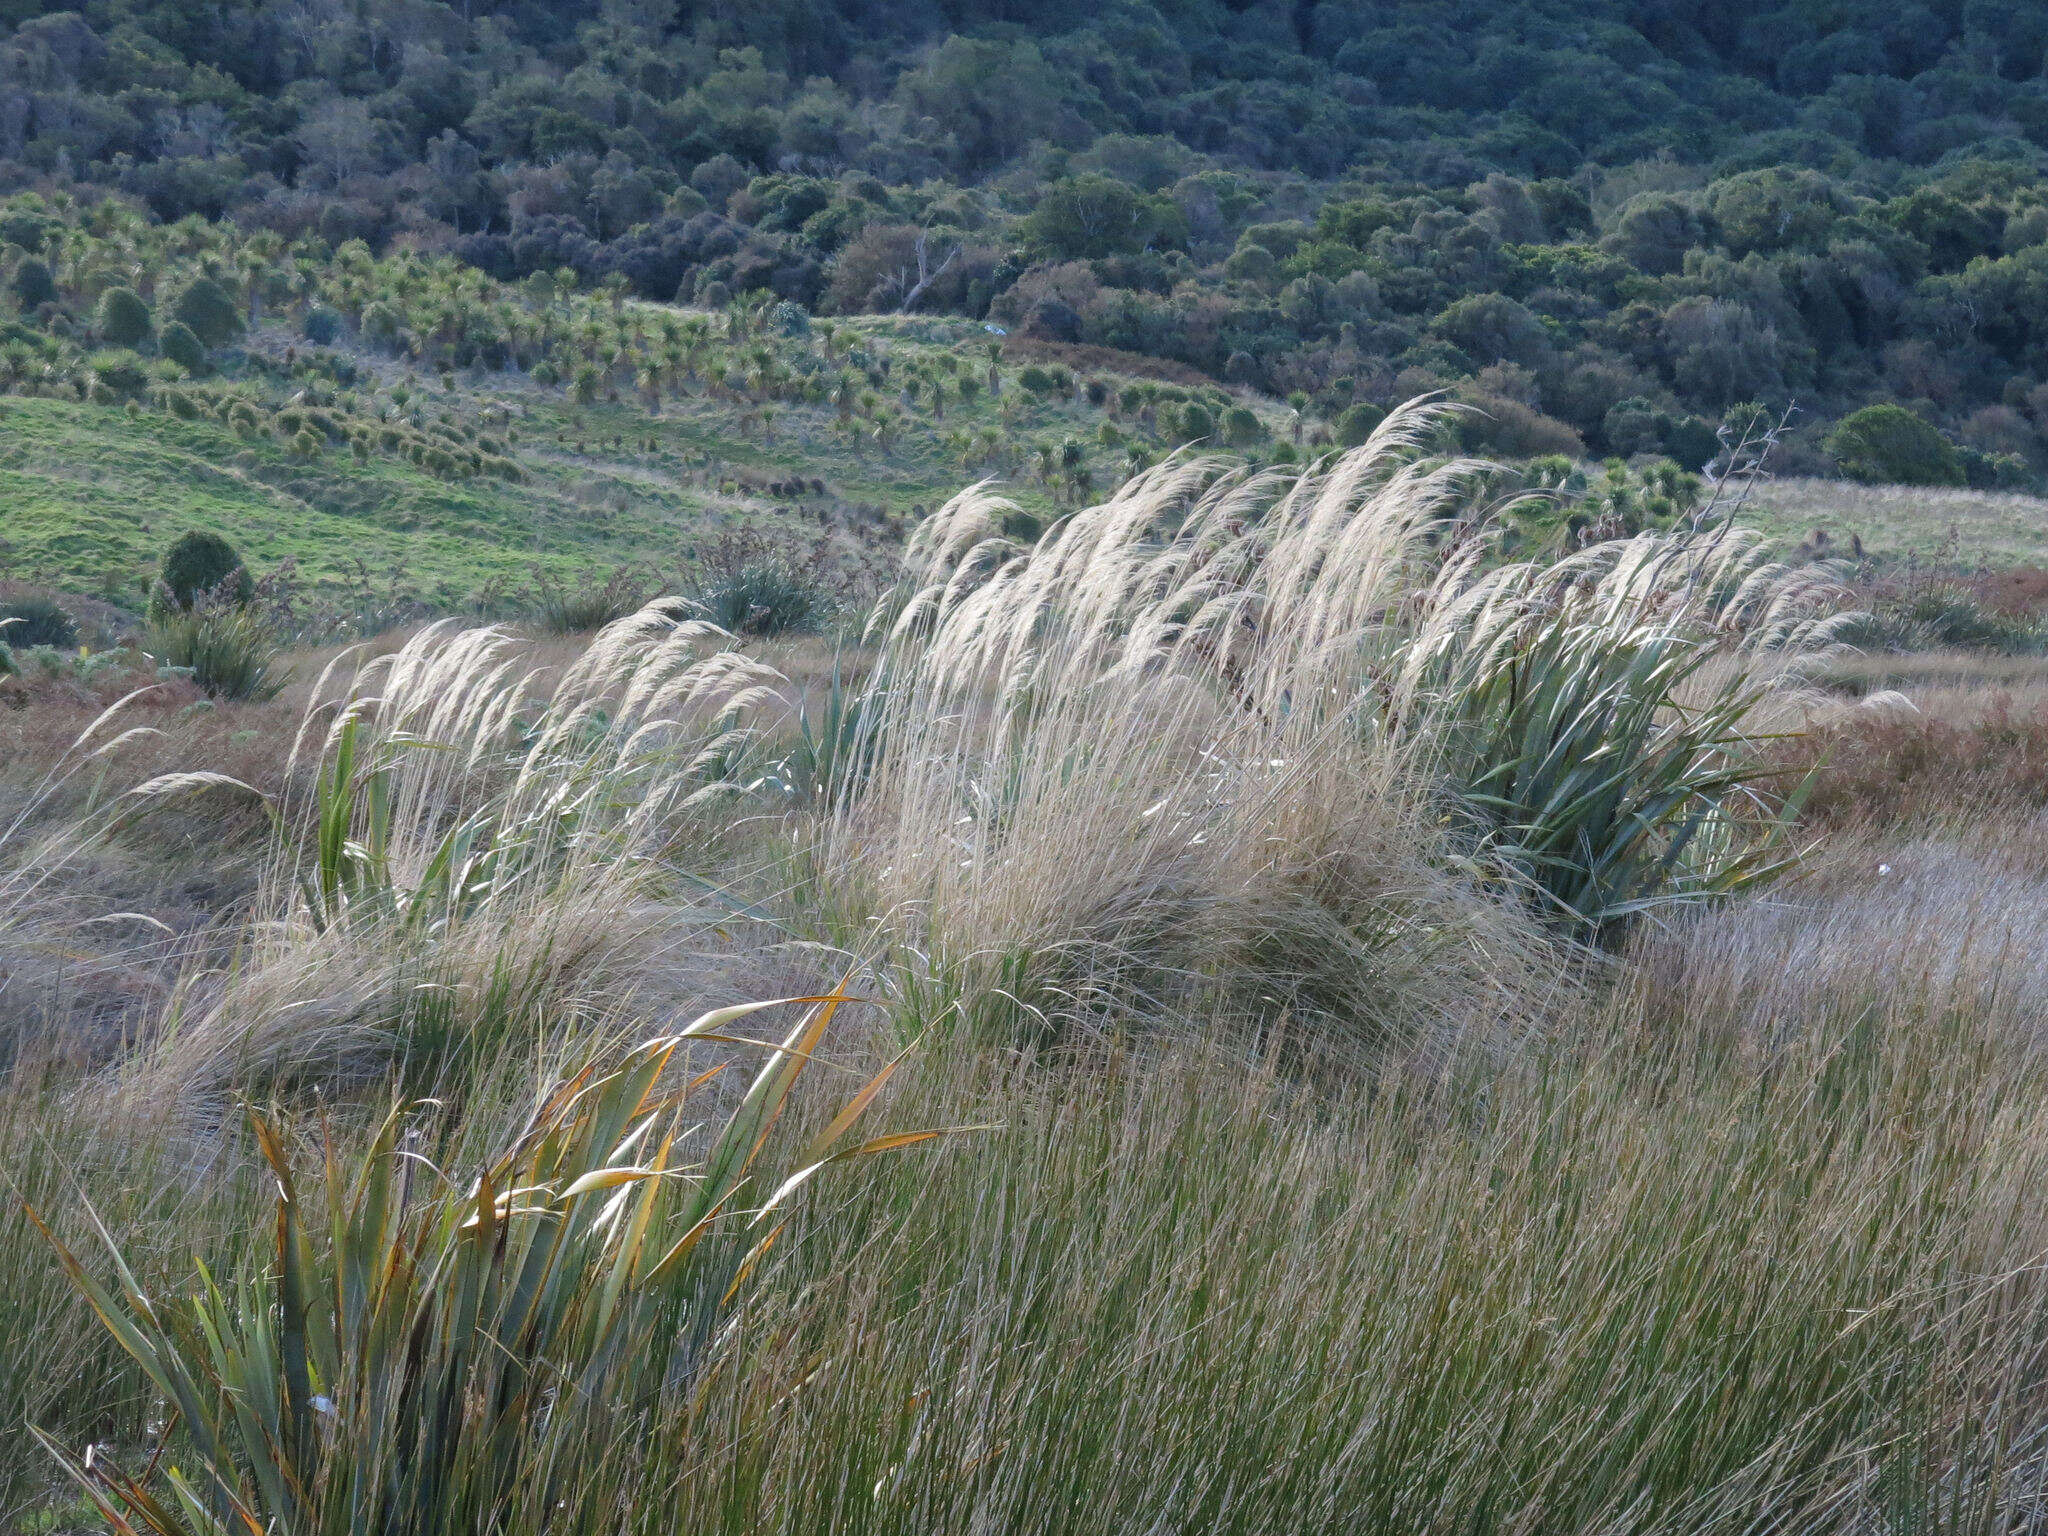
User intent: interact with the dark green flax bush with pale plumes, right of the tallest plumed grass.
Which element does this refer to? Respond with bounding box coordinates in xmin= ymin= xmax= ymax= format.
xmin=1386 ymin=526 xmax=1851 ymax=938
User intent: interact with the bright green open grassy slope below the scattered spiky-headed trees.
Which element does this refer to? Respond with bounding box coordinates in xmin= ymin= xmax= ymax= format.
xmin=0 ymin=309 xmax=1236 ymax=604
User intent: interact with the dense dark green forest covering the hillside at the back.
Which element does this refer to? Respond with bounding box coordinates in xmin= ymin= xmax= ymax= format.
xmin=0 ymin=0 xmax=2048 ymax=485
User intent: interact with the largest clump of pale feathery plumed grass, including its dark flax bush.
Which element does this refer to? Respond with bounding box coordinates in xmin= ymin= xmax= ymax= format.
xmin=825 ymin=401 xmax=1851 ymax=1038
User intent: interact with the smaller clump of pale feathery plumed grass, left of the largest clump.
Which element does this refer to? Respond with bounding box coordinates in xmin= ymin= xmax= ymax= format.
xmin=133 ymin=602 xmax=778 ymax=1102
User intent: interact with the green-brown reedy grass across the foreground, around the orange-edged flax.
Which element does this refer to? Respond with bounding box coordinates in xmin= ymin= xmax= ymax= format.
xmin=19 ymin=958 xmax=2048 ymax=1536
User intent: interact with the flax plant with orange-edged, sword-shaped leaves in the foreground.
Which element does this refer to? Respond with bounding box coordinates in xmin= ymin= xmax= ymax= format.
xmin=27 ymin=987 xmax=946 ymax=1536
